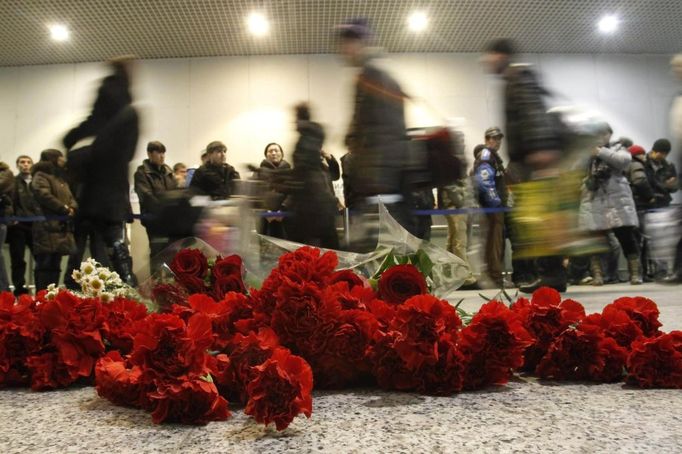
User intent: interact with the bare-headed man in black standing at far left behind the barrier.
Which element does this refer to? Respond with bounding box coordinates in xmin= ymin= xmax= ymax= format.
xmin=7 ymin=155 xmax=36 ymax=296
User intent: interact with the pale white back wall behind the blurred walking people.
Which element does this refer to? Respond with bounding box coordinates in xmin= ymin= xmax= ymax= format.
xmin=0 ymin=54 xmax=678 ymax=172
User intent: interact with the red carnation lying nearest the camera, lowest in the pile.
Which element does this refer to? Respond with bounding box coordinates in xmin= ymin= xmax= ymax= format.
xmin=244 ymin=347 xmax=313 ymax=430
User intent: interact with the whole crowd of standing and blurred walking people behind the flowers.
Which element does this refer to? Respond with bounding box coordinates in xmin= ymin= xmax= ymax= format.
xmin=0 ymin=19 xmax=682 ymax=295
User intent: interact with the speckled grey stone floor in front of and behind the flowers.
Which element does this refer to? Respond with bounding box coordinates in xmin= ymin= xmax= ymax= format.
xmin=0 ymin=284 xmax=682 ymax=454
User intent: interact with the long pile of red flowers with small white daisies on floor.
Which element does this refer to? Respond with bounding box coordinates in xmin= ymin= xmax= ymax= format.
xmin=0 ymin=247 xmax=682 ymax=430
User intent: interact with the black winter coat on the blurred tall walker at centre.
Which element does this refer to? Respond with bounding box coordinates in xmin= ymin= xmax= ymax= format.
xmin=346 ymin=64 xmax=407 ymax=196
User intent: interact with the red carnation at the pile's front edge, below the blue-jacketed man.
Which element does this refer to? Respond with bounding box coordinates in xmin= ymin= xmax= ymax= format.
xmin=459 ymin=301 xmax=533 ymax=389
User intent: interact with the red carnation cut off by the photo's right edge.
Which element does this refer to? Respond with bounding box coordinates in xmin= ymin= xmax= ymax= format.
xmin=627 ymin=331 xmax=682 ymax=389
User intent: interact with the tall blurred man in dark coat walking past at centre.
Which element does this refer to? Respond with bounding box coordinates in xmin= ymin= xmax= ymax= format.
xmin=337 ymin=18 xmax=418 ymax=248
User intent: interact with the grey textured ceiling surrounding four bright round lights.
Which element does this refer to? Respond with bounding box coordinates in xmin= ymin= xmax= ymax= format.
xmin=0 ymin=0 xmax=682 ymax=66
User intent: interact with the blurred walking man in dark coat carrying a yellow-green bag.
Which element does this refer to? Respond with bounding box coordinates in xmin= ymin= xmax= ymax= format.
xmin=484 ymin=39 xmax=566 ymax=292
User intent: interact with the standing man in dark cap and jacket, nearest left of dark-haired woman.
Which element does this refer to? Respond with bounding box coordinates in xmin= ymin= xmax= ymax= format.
xmin=189 ymin=140 xmax=239 ymax=200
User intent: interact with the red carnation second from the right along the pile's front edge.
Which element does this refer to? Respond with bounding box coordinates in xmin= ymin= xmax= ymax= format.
xmin=535 ymin=324 xmax=627 ymax=382
